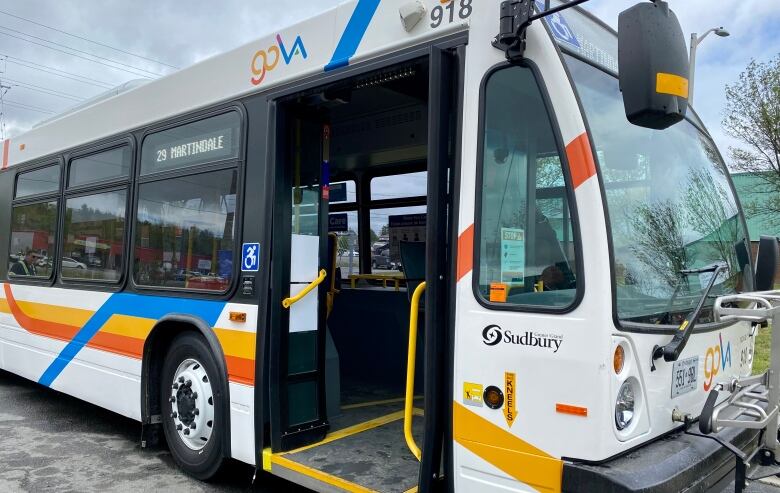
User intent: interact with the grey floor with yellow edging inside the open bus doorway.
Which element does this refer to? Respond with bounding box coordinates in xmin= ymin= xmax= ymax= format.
xmin=283 ymin=399 xmax=424 ymax=493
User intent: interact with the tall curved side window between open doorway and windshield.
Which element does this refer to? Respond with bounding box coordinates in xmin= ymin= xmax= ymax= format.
xmin=476 ymin=66 xmax=577 ymax=309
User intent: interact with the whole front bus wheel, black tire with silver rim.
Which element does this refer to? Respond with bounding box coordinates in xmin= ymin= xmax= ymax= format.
xmin=160 ymin=332 xmax=227 ymax=480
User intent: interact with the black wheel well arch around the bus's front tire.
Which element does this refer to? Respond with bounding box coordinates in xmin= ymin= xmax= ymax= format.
xmin=141 ymin=315 xmax=230 ymax=457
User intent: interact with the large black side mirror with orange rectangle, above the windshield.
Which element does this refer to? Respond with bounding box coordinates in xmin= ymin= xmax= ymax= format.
xmin=618 ymin=0 xmax=689 ymax=130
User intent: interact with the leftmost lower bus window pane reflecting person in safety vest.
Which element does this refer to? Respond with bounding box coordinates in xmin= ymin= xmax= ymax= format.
xmin=8 ymin=200 xmax=57 ymax=279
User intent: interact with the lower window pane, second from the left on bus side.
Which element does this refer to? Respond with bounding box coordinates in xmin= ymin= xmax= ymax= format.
xmin=62 ymin=190 xmax=127 ymax=281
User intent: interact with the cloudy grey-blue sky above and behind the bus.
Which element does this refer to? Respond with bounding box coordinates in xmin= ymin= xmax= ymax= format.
xmin=0 ymin=0 xmax=780 ymax=167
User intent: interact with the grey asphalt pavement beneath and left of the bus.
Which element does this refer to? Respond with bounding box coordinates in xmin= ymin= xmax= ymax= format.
xmin=0 ymin=371 xmax=309 ymax=493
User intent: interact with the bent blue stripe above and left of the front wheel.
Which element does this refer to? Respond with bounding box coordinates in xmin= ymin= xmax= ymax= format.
xmin=38 ymin=293 xmax=225 ymax=387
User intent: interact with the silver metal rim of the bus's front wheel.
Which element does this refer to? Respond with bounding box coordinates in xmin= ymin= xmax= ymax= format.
xmin=170 ymin=359 xmax=214 ymax=450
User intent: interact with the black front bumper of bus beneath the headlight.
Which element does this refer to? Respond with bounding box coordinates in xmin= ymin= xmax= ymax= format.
xmin=562 ymin=427 xmax=759 ymax=493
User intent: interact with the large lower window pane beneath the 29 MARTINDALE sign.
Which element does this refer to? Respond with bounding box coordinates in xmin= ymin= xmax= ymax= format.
xmin=133 ymin=170 xmax=237 ymax=292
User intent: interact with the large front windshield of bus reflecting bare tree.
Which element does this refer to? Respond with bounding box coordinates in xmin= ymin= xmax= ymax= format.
xmin=566 ymin=56 xmax=750 ymax=325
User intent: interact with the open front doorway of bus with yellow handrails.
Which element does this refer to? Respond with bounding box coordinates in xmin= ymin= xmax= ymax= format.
xmin=263 ymin=49 xmax=458 ymax=492
